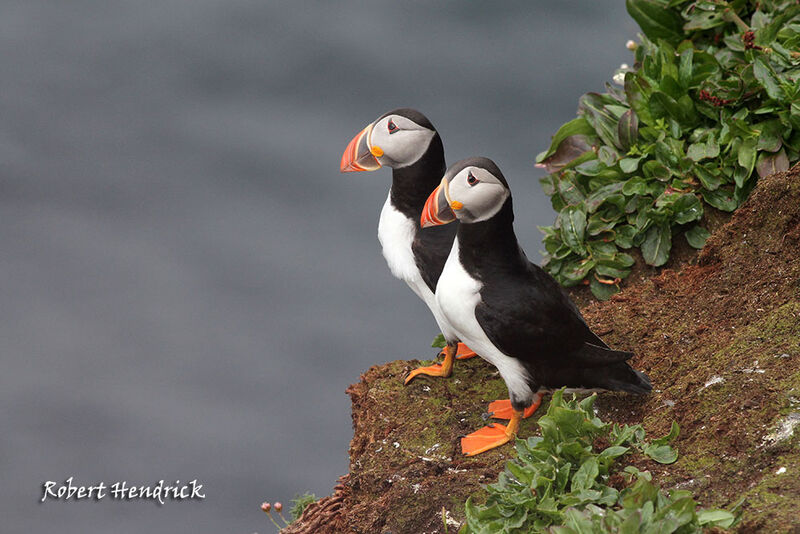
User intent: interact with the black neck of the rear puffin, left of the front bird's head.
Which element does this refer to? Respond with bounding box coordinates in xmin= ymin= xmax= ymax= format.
xmin=391 ymin=133 xmax=447 ymax=224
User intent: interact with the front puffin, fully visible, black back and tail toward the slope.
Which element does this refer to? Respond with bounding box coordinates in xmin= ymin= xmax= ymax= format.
xmin=420 ymin=158 xmax=652 ymax=456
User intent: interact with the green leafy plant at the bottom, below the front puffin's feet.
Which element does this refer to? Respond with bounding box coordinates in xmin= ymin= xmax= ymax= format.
xmin=460 ymin=389 xmax=739 ymax=534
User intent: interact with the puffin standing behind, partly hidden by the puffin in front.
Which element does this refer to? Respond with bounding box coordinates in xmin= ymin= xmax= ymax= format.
xmin=340 ymin=108 xmax=476 ymax=384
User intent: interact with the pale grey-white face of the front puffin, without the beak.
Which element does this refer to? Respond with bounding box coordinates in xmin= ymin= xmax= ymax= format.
xmin=446 ymin=166 xmax=511 ymax=223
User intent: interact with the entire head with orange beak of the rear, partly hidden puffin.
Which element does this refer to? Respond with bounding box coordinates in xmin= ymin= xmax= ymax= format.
xmin=340 ymin=108 xmax=436 ymax=172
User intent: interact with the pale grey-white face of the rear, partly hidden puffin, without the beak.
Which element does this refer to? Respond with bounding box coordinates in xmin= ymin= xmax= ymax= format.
xmin=369 ymin=115 xmax=436 ymax=169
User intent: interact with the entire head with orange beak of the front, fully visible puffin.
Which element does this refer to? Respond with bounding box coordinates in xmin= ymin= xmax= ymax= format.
xmin=420 ymin=158 xmax=511 ymax=228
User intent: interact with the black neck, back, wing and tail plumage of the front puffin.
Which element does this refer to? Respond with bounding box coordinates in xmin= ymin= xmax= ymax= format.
xmin=458 ymin=197 xmax=651 ymax=393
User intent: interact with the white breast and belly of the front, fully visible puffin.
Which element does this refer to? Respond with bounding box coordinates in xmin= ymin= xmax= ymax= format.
xmin=436 ymin=238 xmax=533 ymax=402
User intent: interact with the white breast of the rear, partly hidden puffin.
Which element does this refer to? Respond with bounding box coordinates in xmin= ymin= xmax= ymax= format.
xmin=378 ymin=192 xmax=454 ymax=339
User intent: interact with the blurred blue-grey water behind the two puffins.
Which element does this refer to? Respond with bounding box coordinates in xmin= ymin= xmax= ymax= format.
xmin=0 ymin=0 xmax=636 ymax=534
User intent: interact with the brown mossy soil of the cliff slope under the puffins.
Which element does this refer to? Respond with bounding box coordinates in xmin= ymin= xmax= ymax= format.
xmin=283 ymin=165 xmax=800 ymax=534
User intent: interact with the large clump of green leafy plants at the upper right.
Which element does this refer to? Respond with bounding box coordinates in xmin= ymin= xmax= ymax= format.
xmin=536 ymin=0 xmax=800 ymax=299
